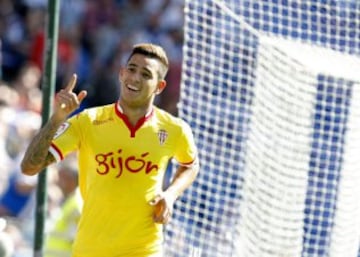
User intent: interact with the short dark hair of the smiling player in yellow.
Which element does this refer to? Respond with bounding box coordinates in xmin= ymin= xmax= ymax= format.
xmin=127 ymin=43 xmax=169 ymax=79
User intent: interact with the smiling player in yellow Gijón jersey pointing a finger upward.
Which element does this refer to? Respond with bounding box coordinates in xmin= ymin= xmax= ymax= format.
xmin=21 ymin=44 xmax=199 ymax=257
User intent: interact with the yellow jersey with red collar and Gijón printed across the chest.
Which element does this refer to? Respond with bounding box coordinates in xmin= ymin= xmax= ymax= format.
xmin=49 ymin=103 xmax=197 ymax=257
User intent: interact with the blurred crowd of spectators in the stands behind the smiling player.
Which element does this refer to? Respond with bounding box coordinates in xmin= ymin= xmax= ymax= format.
xmin=0 ymin=0 xmax=184 ymax=254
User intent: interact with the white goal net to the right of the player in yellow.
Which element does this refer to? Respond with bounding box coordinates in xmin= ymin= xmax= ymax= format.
xmin=165 ymin=0 xmax=360 ymax=257
